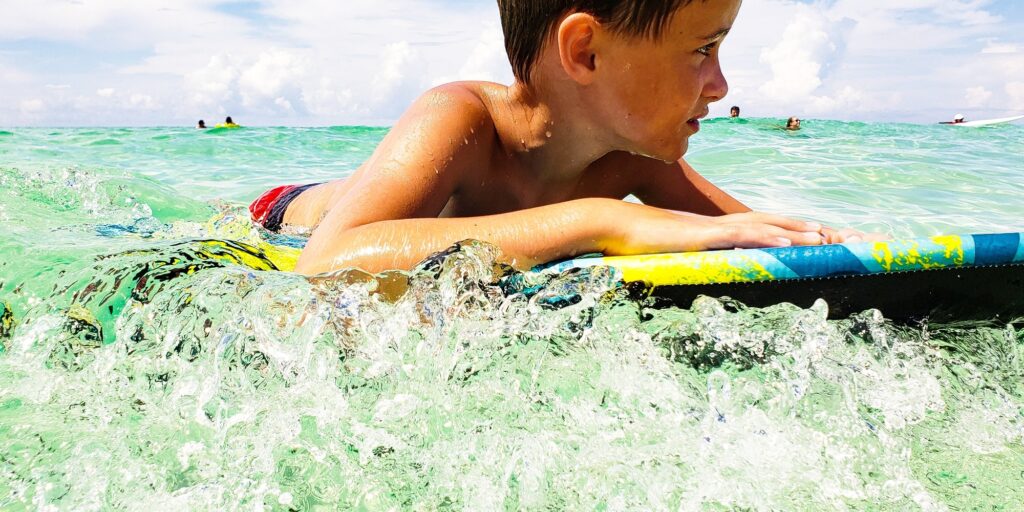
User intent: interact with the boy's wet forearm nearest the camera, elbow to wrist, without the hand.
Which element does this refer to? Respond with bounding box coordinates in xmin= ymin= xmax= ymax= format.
xmin=296 ymin=200 xmax=616 ymax=274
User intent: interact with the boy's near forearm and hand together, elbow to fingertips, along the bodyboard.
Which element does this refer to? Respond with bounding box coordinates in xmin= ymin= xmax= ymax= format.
xmin=296 ymin=198 xmax=821 ymax=274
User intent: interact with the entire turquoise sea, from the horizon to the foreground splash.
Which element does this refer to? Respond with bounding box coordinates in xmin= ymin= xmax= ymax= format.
xmin=0 ymin=120 xmax=1024 ymax=510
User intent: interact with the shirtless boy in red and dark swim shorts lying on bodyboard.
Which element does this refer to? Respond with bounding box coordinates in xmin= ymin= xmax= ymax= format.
xmin=258 ymin=0 xmax=872 ymax=274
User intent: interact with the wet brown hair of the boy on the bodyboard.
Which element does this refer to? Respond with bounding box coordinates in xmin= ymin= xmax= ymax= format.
xmin=498 ymin=0 xmax=693 ymax=82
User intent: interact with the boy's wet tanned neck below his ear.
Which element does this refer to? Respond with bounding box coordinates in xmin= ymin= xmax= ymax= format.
xmin=499 ymin=81 xmax=614 ymax=183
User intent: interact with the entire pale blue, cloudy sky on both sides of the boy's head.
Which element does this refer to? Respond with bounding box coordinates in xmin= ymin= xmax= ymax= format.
xmin=0 ymin=0 xmax=1024 ymax=127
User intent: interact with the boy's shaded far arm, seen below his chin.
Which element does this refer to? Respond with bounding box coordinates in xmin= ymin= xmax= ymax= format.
xmin=627 ymin=156 xmax=751 ymax=216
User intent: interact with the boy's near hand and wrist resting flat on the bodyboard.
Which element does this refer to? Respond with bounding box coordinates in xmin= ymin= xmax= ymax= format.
xmin=600 ymin=202 xmax=824 ymax=255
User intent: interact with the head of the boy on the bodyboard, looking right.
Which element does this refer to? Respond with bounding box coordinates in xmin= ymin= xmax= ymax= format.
xmin=498 ymin=0 xmax=741 ymax=162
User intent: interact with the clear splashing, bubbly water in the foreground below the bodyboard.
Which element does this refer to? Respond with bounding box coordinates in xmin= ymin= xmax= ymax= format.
xmin=0 ymin=204 xmax=1024 ymax=510
